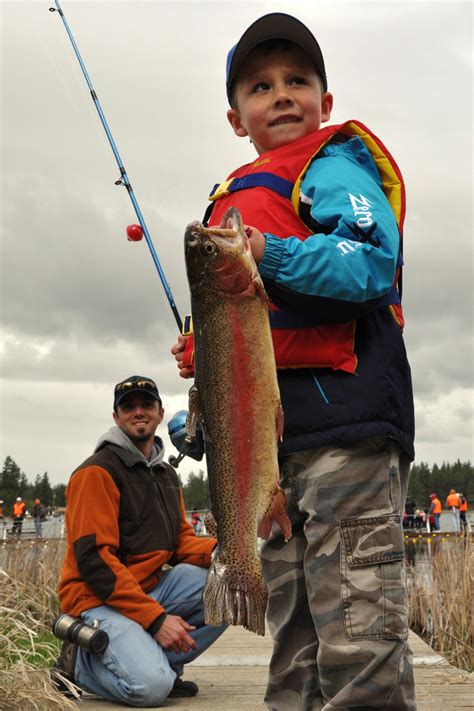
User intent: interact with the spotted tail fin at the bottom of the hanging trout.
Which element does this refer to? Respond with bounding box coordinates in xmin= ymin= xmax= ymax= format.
xmin=203 ymin=557 xmax=268 ymax=636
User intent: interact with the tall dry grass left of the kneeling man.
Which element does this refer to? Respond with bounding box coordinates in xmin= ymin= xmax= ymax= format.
xmin=0 ymin=539 xmax=76 ymax=711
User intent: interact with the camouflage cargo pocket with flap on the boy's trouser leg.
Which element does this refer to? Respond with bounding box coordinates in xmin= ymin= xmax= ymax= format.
xmin=339 ymin=514 xmax=408 ymax=640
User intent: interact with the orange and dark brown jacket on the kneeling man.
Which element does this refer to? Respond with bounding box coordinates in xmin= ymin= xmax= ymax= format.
xmin=58 ymin=446 xmax=216 ymax=632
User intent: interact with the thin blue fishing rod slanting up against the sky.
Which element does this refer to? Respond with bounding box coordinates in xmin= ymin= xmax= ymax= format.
xmin=49 ymin=0 xmax=183 ymax=332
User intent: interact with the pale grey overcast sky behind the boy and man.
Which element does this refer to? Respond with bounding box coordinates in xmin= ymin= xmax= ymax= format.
xmin=0 ymin=0 xmax=473 ymax=486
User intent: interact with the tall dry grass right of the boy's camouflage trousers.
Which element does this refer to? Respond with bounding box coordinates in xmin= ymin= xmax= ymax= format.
xmin=409 ymin=538 xmax=474 ymax=671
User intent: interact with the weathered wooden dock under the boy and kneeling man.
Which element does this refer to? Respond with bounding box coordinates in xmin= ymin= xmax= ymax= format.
xmin=77 ymin=627 xmax=474 ymax=711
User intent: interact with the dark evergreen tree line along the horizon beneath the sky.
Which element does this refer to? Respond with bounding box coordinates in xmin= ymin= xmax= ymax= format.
xmin=0 ymin=457 xmax=474 ymax=513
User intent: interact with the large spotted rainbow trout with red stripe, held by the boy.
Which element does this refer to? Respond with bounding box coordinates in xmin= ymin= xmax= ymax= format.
xmin=185 ymin=208 xmax=291 ymax=635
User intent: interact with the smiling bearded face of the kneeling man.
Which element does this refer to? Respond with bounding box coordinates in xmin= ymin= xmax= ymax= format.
xmin=113 ymin=393 xmax=165 ymax=443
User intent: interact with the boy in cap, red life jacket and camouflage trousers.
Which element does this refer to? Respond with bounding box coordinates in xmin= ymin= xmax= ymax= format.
xmin=172 ymin=13 xmax=415 ymax=711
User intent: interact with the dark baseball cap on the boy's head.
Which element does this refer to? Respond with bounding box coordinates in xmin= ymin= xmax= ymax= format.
xmin=226 ymin=12 xmax=328 ymax=102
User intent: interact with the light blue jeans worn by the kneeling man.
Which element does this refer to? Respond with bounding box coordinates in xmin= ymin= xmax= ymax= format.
xmin=74 ymin=563 xmax=227 ymax=707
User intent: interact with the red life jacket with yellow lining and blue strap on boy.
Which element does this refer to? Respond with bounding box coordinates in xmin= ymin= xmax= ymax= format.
xmin=205 ymin=121 xmax=405 ymax=373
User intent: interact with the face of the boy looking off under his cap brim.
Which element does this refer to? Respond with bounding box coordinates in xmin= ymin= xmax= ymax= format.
xmin=227 ymin=46 xmax=332 ymax=155
